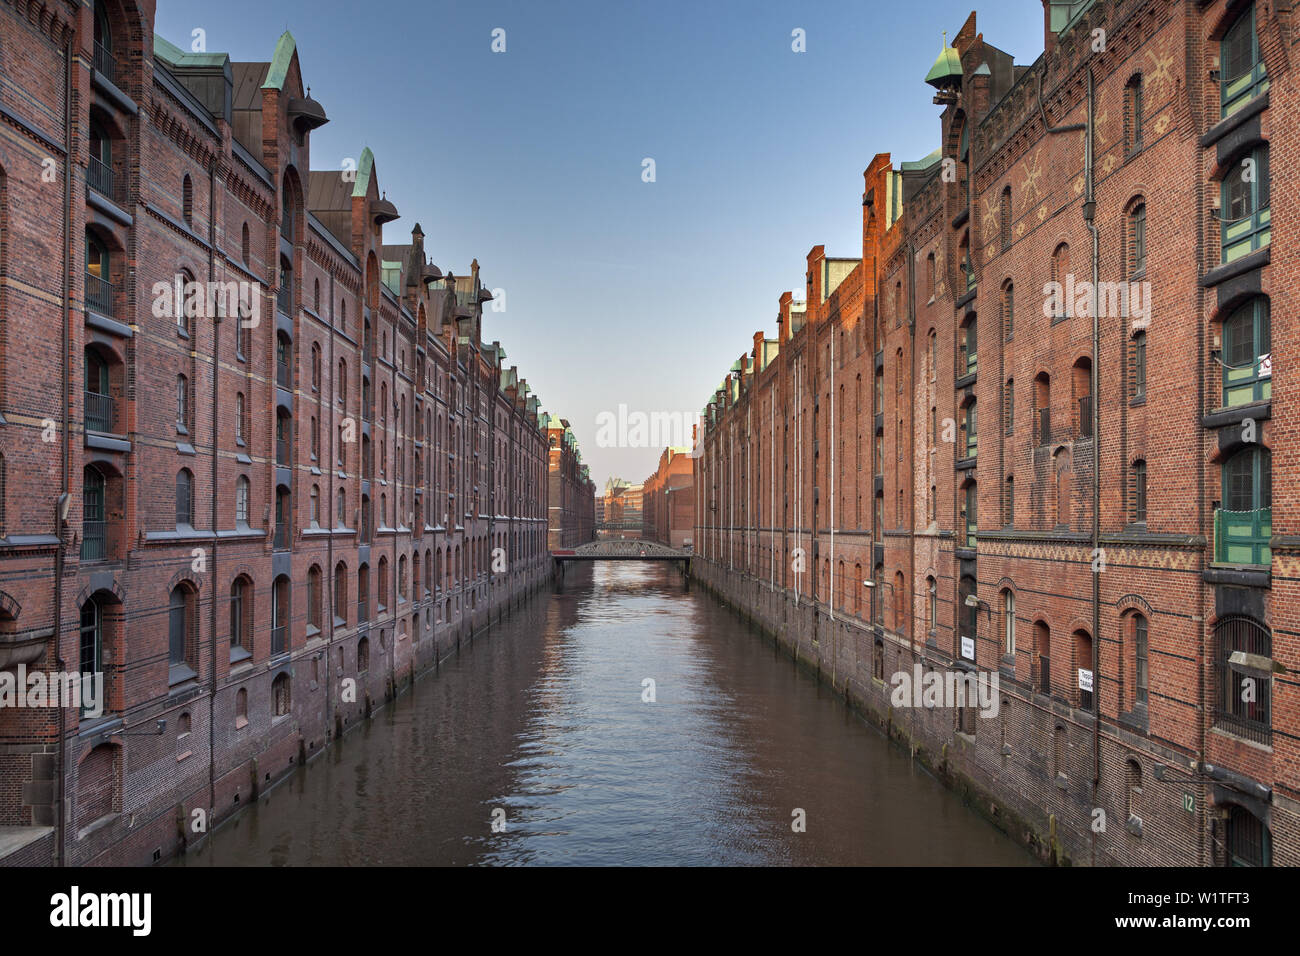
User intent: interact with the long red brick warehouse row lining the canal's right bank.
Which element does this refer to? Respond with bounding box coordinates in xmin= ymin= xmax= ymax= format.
xmin=696 ymin=0 xmax=1300 ymax=865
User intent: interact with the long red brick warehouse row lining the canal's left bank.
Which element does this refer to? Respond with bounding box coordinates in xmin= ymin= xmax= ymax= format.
xmin=0 ymin=0 xmax=579 ymax=864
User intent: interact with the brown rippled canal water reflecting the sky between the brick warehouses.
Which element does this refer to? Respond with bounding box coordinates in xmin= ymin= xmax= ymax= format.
xmin=178 ymin=562 xmax=1034 ymax=866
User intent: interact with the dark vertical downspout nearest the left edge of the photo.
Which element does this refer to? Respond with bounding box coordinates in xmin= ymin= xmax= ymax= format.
xmin=53 ymin=30 xmax=73 ymax=866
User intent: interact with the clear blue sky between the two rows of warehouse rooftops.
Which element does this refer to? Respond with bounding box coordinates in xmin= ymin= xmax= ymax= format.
xmin=156 ymin=0 xmax=1043 ymax=485
